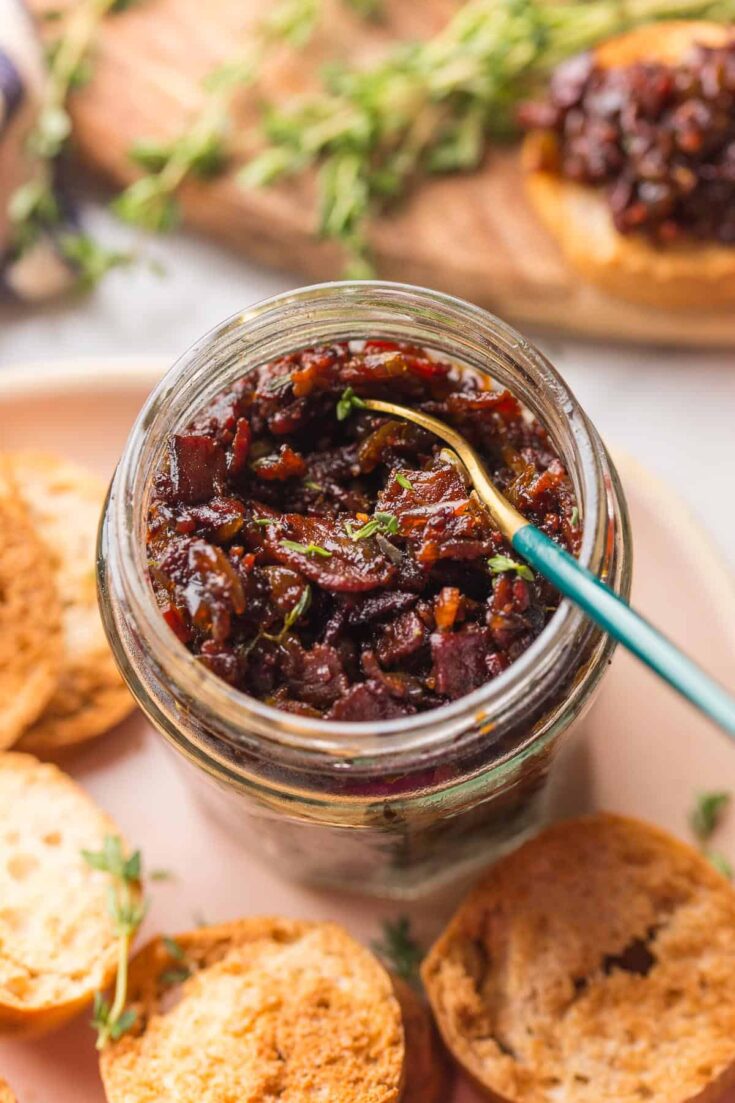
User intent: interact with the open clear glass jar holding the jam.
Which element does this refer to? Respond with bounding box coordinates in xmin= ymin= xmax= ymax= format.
xmin=99 ymin=282 xmax=631 ymax=899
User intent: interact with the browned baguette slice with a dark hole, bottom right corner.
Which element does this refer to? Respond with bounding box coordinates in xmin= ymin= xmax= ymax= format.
xmin=422 ymin=814 xmax=735 ymax=1103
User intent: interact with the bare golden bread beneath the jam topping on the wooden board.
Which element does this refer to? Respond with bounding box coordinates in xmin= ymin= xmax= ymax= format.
xmin=523 ymin=21 xmax=735 ymax=310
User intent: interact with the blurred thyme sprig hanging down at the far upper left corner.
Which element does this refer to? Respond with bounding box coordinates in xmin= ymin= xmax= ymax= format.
xmin=8 ymin=0 xmax=134 ymax=290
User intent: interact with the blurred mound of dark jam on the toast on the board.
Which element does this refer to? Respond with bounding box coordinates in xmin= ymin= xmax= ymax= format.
xmin=520 ymin=40 xmax=735 ymax=245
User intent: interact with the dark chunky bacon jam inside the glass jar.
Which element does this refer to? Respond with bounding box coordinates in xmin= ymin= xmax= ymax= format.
xmin=148 ymin=340 xmax=579 ymax=720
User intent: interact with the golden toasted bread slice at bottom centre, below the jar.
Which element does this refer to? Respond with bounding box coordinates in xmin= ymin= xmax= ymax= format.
xmin=100 ymin=918 xmax=405 ymax=1103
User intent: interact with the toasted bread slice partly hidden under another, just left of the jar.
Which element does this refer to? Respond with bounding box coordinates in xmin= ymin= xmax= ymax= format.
xmin=10 ymin=452 xmax=134 ymax=754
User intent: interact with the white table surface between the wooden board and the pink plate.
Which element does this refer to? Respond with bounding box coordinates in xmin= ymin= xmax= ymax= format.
xmin=0 ymin=206 xmax=735 ymax=566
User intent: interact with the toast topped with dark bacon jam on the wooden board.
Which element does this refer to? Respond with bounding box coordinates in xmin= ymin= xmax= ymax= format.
xmin=521 ymin=21 xmax=735 ymax=309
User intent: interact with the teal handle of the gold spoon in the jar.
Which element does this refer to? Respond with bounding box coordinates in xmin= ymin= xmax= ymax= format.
xmin=512 ymin=525 xmax=735 ymax=737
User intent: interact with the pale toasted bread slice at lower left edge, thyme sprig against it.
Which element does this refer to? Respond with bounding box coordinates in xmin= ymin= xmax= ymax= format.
xmin=0 ymin=752 xmax=124 ymax=1034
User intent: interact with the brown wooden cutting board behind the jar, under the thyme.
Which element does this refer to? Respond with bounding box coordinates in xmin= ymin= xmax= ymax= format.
xmin=32 ymin=0 xmax=735 ymax=345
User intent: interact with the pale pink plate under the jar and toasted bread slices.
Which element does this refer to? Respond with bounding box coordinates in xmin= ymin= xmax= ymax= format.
xmin=0 ymin=363 xmax=735 ymax=1103
